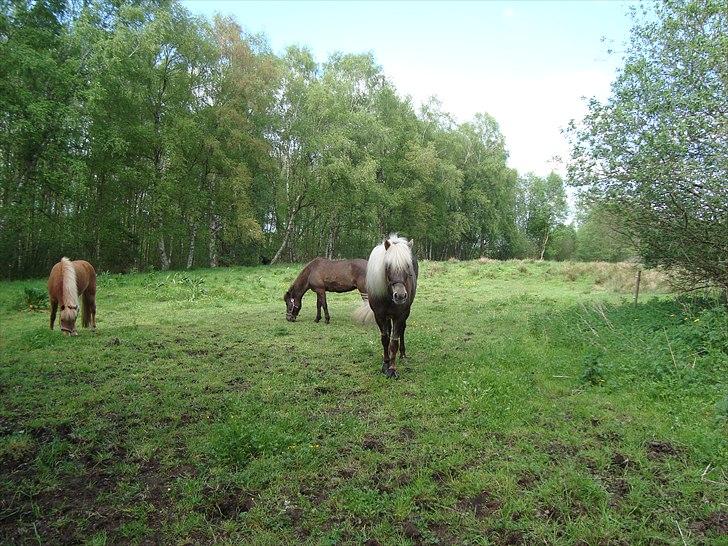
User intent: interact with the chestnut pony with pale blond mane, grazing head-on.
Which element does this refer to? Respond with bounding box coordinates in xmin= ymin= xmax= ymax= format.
xmin=48 ymin=258 xmax=96 ymax=336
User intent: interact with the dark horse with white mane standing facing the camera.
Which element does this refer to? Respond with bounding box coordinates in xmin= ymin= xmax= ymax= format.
xmin=367 ymin=233 xmax=419 ymax=377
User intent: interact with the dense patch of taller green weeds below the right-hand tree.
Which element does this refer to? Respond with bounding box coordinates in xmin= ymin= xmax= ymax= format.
xmin=544 ymin=297 xmax=728 ymax=412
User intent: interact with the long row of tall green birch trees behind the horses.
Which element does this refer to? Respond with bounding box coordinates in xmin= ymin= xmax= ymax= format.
xmin=0 ymin=0 xmax=632 ymax=278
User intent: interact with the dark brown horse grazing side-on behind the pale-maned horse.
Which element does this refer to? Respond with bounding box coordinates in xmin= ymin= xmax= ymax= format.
xmin=283 ymin=258 xmax=367 ymax=324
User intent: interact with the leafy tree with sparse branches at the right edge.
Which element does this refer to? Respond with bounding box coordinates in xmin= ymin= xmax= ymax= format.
xmin=569 ymin=0 xmax=728 ymax=287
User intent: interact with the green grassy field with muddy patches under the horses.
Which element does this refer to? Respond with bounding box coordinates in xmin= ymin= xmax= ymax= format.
xmin=0 ymin=260 xmax=728 ymax=545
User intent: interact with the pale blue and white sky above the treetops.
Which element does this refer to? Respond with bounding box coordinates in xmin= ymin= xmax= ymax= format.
xmin=183 ymin=0 xmax=630 ymax=176
